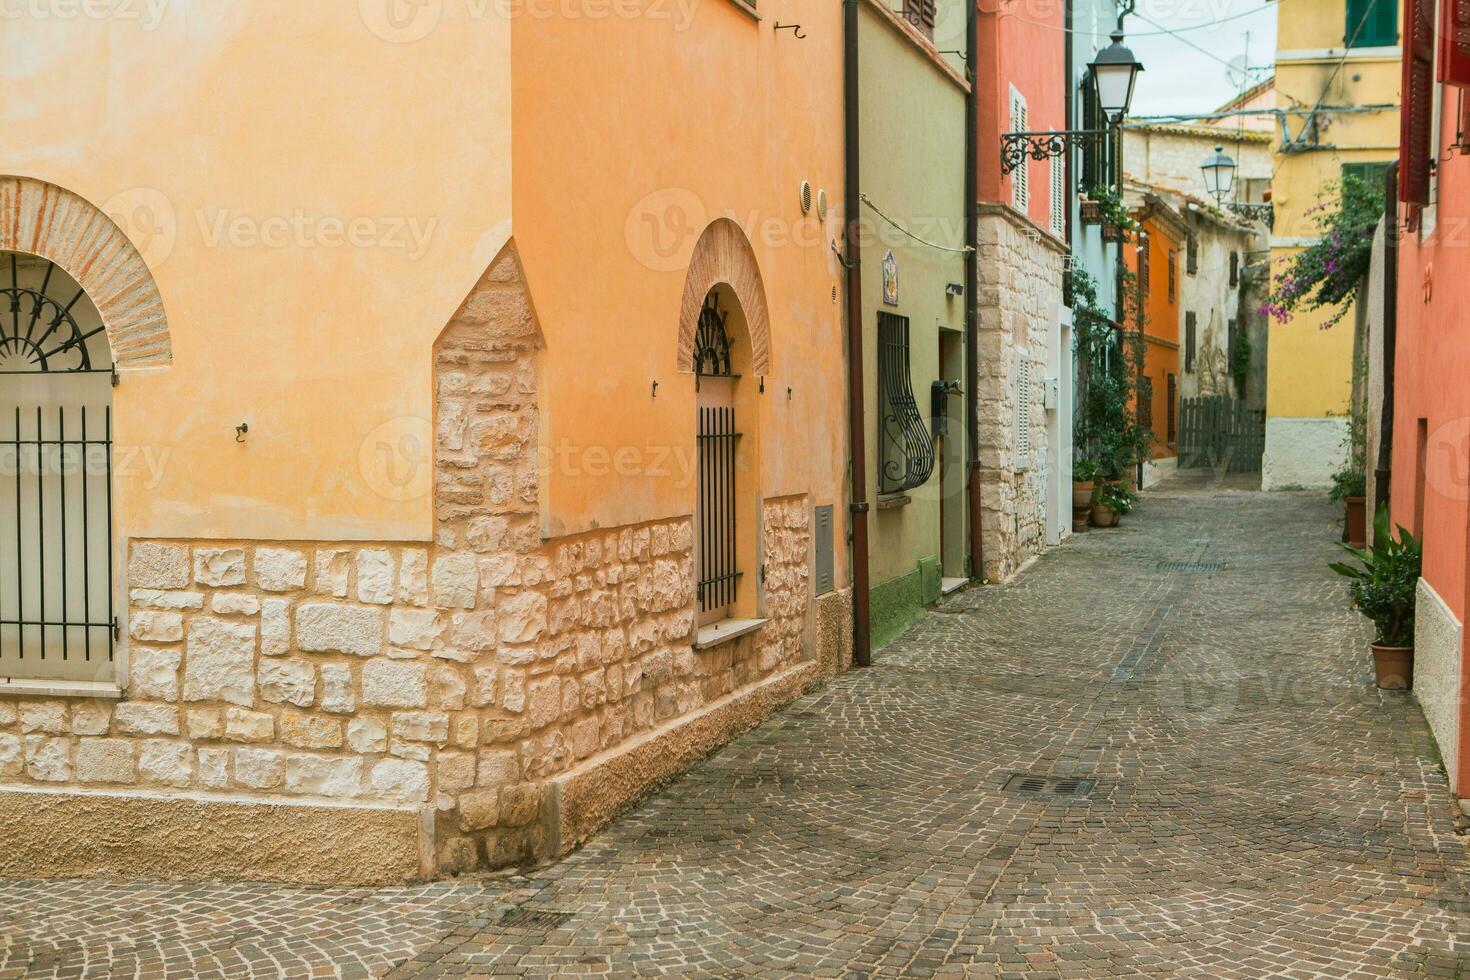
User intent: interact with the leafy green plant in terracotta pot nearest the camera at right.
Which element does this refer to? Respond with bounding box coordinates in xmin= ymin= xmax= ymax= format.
xmin=1332 ymin=504 xmax=1423 ymax=691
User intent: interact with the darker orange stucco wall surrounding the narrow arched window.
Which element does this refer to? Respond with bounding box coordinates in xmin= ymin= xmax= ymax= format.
xmin=512 ymin=0 xmax=845 ymax=575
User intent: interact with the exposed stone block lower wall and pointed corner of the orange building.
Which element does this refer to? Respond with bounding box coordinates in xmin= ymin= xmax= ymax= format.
xmin=0 ymin=240 xmax=813 ymax=873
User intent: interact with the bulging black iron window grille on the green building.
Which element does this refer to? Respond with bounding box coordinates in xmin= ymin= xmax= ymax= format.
xmin=878 ymin=313 xmax=933 ymax=494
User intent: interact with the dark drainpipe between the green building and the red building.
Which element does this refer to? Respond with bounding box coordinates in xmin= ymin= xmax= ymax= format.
xmin=964 ymin=0 xmax=985 ymax=579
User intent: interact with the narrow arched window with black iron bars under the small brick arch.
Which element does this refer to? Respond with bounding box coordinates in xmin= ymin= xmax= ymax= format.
xmin=694 ymin=292 xmax=741 ymax=621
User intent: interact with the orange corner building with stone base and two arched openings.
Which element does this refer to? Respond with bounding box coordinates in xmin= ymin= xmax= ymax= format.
xmin=0 ymin=4 xmax=853 ymax=883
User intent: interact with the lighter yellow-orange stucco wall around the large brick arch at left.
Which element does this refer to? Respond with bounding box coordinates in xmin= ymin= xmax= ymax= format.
xmin=0 ymin=0 xmax=510 ymax=539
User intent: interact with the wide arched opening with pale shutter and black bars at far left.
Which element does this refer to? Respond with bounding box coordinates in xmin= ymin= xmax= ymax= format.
xmin=0 ymin=250 xmax=116 ymax=680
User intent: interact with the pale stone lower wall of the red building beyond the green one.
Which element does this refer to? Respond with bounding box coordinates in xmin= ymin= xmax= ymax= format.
xmin=975 ymin=204 xmax=1063 ymax=582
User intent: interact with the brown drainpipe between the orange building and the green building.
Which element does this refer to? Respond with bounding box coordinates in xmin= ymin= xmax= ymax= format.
xmin=842 ymin=0 xmax=873 ymax=667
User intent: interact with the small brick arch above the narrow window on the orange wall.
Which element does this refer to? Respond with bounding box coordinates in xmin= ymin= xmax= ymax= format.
xmin=679 ymin=217 xmax=770 ymax=375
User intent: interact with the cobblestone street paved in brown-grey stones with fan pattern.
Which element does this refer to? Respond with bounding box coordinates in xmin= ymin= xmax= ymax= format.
xmin=0 ymin=486 xmax=1470 ymax=977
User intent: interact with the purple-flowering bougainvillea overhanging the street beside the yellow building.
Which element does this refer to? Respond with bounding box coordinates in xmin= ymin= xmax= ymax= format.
xmin=1261 ymin=173 xmax=1383 ymax=329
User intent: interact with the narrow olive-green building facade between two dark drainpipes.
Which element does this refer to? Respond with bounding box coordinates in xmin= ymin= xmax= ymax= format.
xmin=858 ymin=0 xmax=970 ymax=646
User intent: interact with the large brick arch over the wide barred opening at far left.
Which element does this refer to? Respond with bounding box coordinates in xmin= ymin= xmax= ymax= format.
xmin=0 ymin=176 xmax=173 ymax=372
